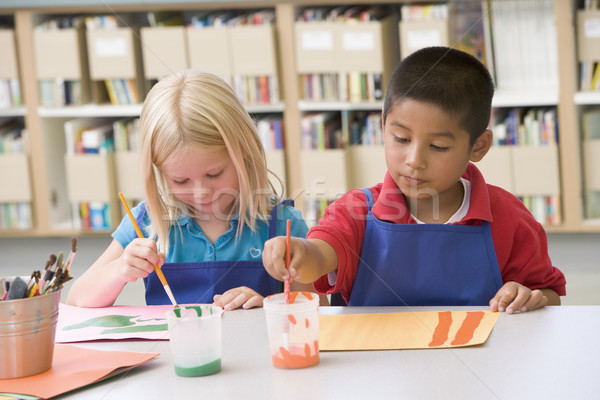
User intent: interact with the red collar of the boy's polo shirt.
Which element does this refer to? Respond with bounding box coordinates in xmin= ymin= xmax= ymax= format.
xmin=371 ymin=163 xmax=493 ymax=224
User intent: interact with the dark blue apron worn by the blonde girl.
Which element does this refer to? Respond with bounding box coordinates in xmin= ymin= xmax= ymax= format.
xmin=144 ymin=200 xmax=294 ymax=305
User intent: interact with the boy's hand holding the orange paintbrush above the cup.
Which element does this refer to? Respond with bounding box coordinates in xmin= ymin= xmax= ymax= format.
xmin=263 ymin=236 xmax=305 ymax=281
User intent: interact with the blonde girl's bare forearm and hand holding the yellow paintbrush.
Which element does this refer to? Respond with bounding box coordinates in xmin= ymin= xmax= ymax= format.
xmin=66 ymin=239 xmax=164 ymax=307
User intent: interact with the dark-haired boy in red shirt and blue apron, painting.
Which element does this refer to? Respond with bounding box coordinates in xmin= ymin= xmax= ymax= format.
xmin=263 ymin=47 xmax=566 ymax=314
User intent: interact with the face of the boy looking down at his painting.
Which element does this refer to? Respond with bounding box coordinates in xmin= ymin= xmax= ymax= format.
xmin=383 ymin=99 xmax=491 ymax=207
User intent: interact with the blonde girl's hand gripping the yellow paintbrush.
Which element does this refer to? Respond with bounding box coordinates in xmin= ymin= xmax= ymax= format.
xmin=118 ymin=238 xmax=165 ymax=282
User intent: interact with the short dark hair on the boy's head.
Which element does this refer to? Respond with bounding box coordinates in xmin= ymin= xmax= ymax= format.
xmin=383 ymin=47 xmax=494 ymax=144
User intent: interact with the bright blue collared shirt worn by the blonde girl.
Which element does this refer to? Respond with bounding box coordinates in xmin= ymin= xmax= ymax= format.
xmin=112 ymin=202 xmax=308 ymax=263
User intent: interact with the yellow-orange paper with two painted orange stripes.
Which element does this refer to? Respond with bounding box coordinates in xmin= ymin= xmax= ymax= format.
xmin=319 ymin=311 xmax=500 ymax=351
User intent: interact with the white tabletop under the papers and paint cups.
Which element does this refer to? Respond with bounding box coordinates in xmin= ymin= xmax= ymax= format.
xmin=54 ymin=306 xmax=600 ymax=400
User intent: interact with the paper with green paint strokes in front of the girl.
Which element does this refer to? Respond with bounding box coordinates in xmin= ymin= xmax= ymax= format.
xmin=55 ymin=303 xmax=173 ymax=343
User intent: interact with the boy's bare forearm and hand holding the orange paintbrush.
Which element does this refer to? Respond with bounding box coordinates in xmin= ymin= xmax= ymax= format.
xmin=263 ymin=236 xmax=338 ymax=283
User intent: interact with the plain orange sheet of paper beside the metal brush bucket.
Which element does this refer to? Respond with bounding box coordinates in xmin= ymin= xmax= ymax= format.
xmin=0 ymin=344 xmax=160 ymax=399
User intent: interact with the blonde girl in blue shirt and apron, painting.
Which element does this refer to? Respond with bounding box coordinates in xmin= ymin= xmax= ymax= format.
xmin=67 ymin=70 xmax=310 ymax=309
